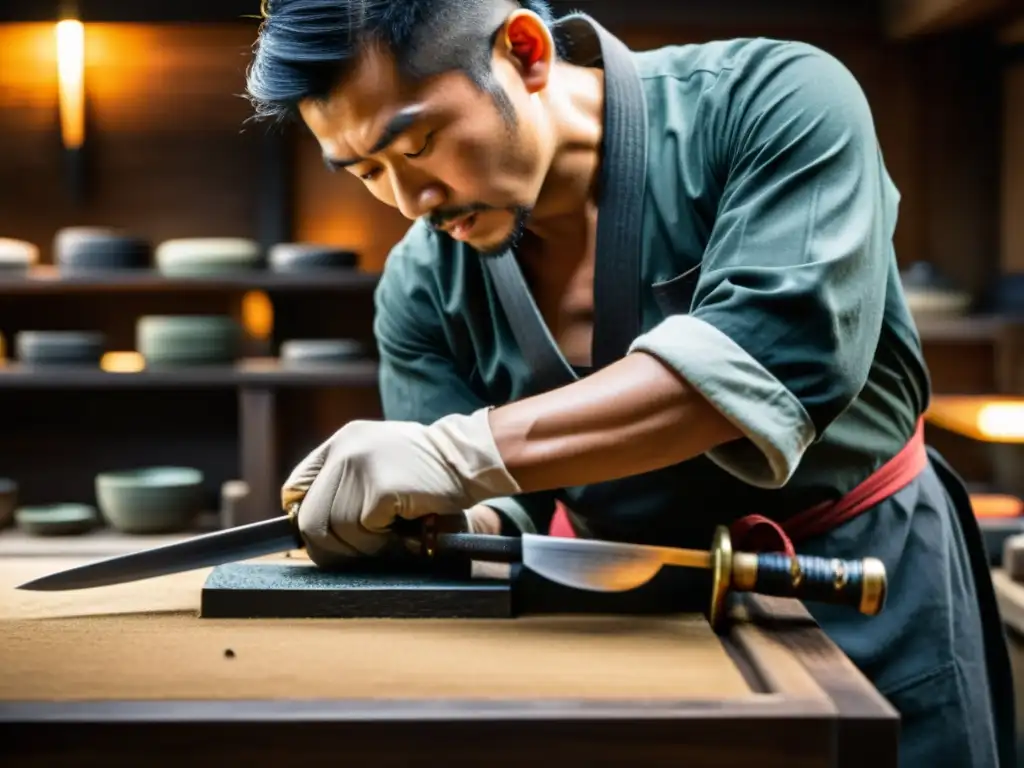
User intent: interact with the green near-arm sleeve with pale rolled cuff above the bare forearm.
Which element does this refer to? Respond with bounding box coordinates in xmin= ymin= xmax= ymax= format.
xmin=631 ymin=44 xmax=898 ymax=487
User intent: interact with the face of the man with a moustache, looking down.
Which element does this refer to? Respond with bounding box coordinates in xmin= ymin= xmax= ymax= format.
xmin=300 ymin=36 xmax=546 ymax=253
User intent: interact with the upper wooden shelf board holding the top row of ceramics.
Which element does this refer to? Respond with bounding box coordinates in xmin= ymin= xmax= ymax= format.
xmin=0 ymin=266 xmax=380 ymax=295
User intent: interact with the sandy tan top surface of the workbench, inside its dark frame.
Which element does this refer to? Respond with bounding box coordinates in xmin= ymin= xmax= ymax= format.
xmin=0 ymin=556 xmax=754 ymax=701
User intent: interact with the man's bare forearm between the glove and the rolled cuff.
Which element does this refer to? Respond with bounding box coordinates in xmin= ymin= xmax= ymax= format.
xmin=490 ymin=353 xmax=740 ymax=493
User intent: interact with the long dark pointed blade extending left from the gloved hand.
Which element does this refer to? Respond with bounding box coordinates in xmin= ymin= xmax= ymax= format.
xmin=17 ymin=515 xmax=304 ymax=592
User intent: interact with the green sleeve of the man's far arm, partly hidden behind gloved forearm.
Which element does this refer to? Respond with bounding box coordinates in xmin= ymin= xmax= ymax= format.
xmin=374 ymin=244 xmax=555 ymax=535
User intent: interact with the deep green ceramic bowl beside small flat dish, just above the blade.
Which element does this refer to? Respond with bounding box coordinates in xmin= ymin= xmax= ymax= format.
xmin=96 ymin=467 xmax=203 ymax=534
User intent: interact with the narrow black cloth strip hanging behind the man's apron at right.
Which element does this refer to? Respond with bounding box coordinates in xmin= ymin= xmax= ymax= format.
xmin=928 ymin=446 xmax=1017 ymax=768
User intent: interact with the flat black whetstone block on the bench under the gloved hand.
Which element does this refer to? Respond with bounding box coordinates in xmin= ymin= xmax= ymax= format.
xmin=200 ymin=563 xmax=513 ymax=618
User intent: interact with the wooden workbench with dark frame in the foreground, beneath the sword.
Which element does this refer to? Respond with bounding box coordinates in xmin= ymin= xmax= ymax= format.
xmin=0 ymin=557 xmax=898 ymax=768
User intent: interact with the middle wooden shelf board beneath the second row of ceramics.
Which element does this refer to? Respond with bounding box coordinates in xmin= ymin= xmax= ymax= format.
xmin=0 ymin=357 xmax=377 ymax=389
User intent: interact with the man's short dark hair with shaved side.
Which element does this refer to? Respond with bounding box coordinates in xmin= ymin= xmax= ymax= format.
xmin=247 ymin=0 xmax=554 ymax=120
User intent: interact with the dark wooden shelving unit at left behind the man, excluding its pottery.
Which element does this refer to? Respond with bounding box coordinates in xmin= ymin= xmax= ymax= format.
xmin=0 ymin=265 xmax=380 ymax=544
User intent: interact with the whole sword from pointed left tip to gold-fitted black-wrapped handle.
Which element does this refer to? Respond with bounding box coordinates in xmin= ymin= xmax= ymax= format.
xmin=12 ymin=514 xmax=886 ymax=626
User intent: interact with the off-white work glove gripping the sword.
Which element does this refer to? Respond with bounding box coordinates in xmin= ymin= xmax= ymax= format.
xmin=282 ymin=409 xmax=520 ymax=566
